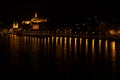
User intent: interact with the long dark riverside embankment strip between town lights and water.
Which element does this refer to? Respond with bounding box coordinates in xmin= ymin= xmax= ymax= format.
xmin=0 ymin=29 xmax=120 ymax=40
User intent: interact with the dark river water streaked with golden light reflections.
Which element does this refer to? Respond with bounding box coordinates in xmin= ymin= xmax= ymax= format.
xmin=0 ymin=35 xmax=120 ymax=80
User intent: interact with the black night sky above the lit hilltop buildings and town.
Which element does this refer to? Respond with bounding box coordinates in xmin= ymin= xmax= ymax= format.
xmin=0 ymin=0 xmax=120 ymax=21
